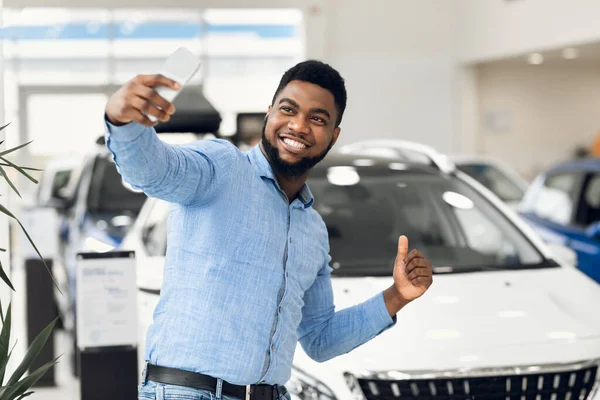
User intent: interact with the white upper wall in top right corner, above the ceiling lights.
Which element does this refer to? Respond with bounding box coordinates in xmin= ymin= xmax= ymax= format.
xmin=454 ymin=0 xmax=600 ymax=63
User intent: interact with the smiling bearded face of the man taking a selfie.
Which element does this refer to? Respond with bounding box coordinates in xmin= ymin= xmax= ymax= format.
xmin=262 ymin=81 xmax=340 ymax=178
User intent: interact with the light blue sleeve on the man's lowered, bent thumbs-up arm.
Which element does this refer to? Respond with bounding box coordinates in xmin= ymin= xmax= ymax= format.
xmin=297 ymin=263 xmax=396 ymax=362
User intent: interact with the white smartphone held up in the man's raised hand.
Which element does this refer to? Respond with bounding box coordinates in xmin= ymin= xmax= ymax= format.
xmin=147 ymin=47 xmax=200 ymax=122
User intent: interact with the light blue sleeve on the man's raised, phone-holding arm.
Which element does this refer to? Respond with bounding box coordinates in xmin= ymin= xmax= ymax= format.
xmin=105 ymin=121 xmax=237 ymax=204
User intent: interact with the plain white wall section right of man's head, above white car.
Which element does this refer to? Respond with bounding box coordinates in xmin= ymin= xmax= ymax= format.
xmin=326 ymin=0 xmax=457 ymax=151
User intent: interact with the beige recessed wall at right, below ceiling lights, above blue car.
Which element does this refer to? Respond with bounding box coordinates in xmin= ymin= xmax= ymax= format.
xmin=477 ymin=65 xmax=600 ymax=177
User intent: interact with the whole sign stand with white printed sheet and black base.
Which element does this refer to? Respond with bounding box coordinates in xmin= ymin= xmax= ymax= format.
xmin=76 ymin=251 xmax=138 ymax=400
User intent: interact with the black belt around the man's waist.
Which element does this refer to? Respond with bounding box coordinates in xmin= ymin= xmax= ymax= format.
xmin=144 ymin=364 xmax=287 ymax=400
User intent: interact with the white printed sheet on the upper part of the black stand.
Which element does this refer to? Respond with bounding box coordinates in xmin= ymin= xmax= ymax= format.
xmin=76 ymin=251 xmax=138 ymax=349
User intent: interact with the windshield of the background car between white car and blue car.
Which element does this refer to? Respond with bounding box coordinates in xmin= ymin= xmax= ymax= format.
xmin=457 ymin=163 xmax=525 ymax=201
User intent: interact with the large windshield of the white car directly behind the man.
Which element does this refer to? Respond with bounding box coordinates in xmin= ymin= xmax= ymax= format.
xmin=309 ymin=168 xmax=548 ymax=276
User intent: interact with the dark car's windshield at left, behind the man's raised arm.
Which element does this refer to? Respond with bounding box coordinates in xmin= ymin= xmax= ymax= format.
xmin=88 ymin=157 xmax=146 ymax=215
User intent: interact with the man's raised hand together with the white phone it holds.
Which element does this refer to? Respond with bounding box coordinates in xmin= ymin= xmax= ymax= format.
xmin=105 ymin=48 xmax=200 ymax=126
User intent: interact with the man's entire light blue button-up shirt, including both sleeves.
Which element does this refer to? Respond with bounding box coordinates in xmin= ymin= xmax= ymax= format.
xmin=106 ymin=122 xmax=394 ymax=385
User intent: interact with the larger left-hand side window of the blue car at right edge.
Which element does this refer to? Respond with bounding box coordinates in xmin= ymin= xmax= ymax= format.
xmin=533 ymin=173 xmax=581 ymax=225
